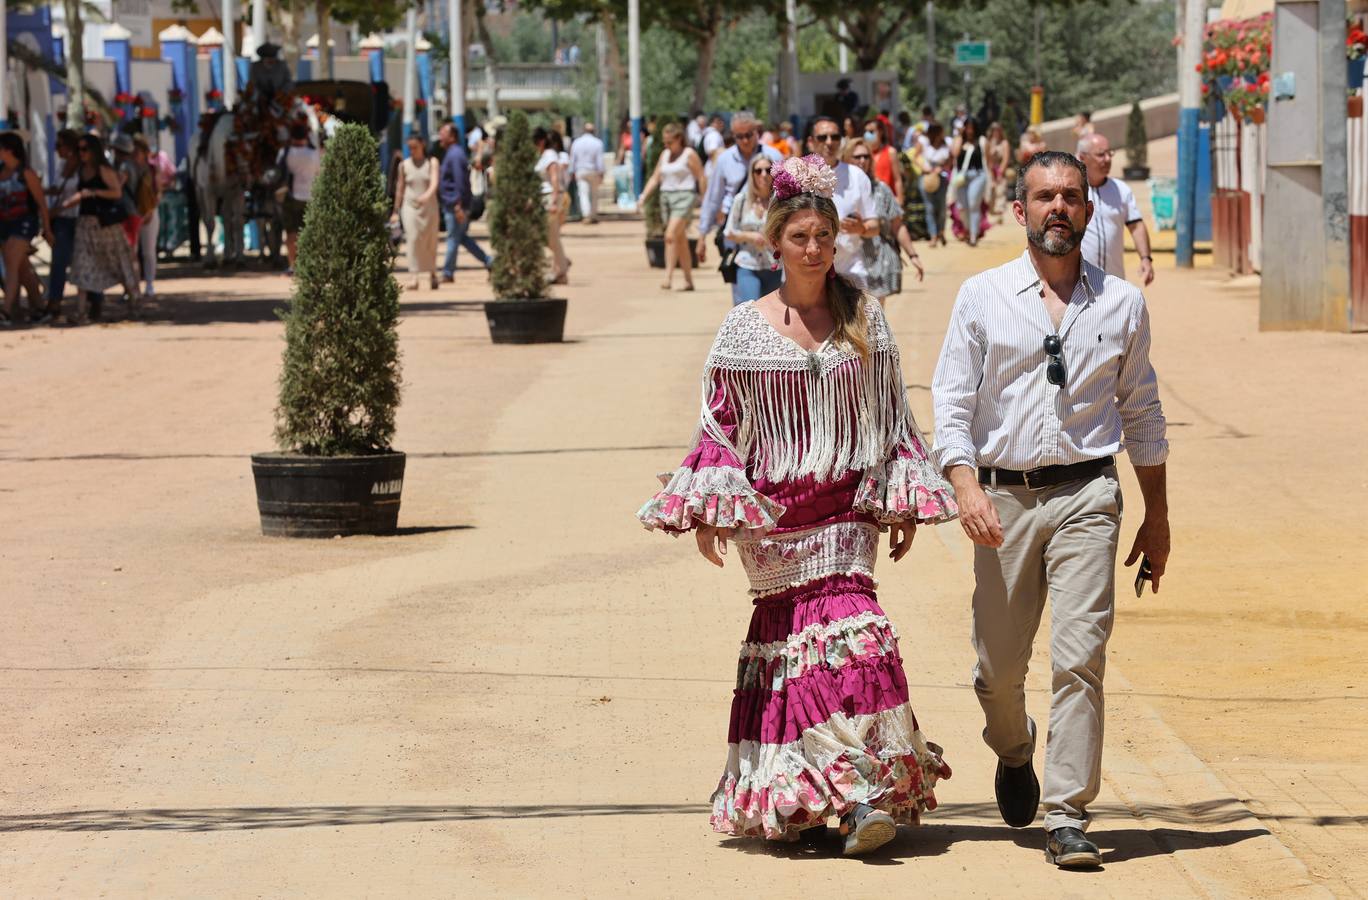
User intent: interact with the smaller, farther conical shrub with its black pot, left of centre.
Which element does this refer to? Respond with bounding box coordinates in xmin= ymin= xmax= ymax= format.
xmin=484 ymin=109 xmax=565 ymax=343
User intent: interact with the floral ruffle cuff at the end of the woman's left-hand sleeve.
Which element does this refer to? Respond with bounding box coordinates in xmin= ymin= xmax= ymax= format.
xmin=636 ymin=466 xmax=784 ymax=540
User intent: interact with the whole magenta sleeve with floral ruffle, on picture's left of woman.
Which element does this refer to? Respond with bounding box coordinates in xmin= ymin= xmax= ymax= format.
xmin=636 ymin=378 xmax=784 ymax=540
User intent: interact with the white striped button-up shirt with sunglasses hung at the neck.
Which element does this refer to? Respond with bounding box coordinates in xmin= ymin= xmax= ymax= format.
xmin=932 ymin=244 xmax=1168 ymax=471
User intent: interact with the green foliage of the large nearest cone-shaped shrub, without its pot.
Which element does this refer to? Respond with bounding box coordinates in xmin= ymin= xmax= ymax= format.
xmin=275 ymin=124 xmax=399 ymax=455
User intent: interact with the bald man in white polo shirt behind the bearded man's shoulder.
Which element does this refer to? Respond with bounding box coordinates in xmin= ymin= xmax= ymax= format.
xmin=1078 ymin=133 xmax=1155 ymax=287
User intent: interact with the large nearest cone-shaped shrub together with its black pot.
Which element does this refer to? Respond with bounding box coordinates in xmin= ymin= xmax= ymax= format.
xmin=252 ymin=124 xmax=405 ymax=538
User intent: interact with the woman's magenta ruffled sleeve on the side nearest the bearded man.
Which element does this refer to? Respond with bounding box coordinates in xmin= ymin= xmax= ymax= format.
xmin=855 ymin=305 xmax=959 ymax=525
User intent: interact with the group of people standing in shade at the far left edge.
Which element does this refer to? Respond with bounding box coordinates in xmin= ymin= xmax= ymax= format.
xmin=0 ymin=124 xmax=175 ymax=328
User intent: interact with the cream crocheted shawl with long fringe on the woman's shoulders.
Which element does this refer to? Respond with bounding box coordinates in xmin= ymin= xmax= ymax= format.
xmin=700 ymin=298 xmax=925 ymax=481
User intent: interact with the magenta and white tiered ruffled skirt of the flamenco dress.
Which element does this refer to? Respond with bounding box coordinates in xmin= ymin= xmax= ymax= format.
xmin=711 ymin=549 xmax=949 ymax=840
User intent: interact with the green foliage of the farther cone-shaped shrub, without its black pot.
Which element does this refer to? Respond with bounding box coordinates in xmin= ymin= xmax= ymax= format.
xmin=490 ymin=109 xmax=547 ymax=300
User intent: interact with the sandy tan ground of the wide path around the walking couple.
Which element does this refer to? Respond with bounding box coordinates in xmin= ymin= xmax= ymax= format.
xmin=0 ymin=207 xmax=1346 ymax=897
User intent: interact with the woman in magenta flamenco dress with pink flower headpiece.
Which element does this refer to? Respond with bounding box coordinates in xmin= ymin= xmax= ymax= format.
xmin=637 ymin=156 xmax=956 ymax=855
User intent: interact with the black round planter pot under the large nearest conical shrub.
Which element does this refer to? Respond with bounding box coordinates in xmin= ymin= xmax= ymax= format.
xmin=252 ymin=453 xmax=405 ymax=538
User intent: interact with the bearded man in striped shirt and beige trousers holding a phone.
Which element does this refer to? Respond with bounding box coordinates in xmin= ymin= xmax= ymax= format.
xmin=932 ymin=152 xmax=1168 ymax=867
